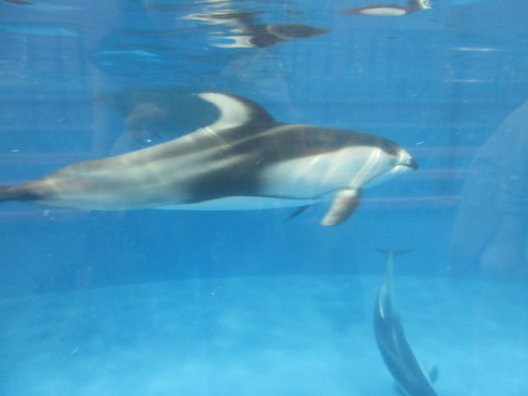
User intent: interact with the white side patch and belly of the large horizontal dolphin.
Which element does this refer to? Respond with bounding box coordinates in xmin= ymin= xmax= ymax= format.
xmin=159 ymin=147 xmax=392 ymax=210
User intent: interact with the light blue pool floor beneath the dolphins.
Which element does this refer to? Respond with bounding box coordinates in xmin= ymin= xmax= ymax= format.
xmin=0 ymin=276 xmax=528 ymax=396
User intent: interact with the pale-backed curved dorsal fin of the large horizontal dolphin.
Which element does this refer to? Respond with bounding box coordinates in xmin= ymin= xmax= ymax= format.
xmin=198 ymin=92 xmax=276 ymax=131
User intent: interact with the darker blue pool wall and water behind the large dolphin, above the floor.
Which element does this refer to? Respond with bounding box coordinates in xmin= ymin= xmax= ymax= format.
xmin=0 ymin=1 xmax=528 ymax=295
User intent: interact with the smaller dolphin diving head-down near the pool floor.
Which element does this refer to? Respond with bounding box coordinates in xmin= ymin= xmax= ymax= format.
xmin=374 ymin=249 xmax=438 ymax=396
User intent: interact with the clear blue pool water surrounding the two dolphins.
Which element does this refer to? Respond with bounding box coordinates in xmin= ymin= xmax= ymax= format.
xmin=0 ymin=0 xmax=528 ymax=396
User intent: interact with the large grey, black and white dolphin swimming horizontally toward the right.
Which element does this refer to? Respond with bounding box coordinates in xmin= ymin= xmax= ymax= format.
xmin=0 ymin=93 xmax=417 ymax=226
